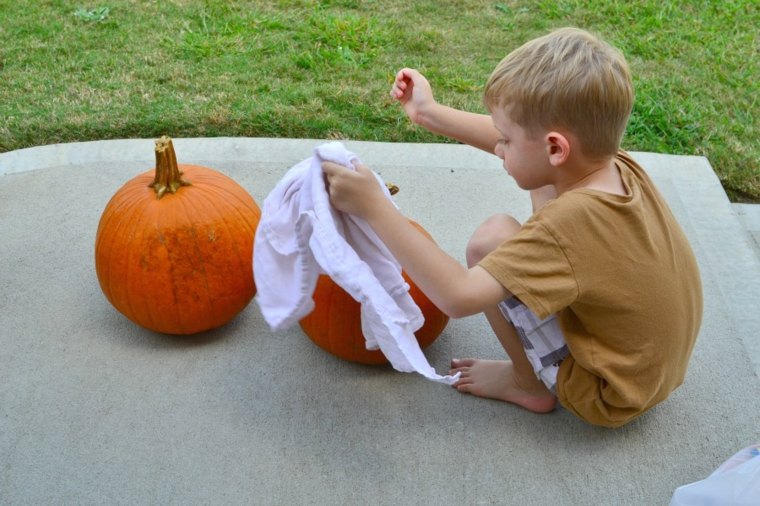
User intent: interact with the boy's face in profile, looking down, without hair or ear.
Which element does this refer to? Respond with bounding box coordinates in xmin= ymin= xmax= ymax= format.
xmin=491 ymin=107 xmax=553 ymax=190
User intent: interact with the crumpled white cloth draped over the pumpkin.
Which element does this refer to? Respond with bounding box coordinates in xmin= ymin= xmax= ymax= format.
xmin=253 ymin=142 xmax=459 ymax=385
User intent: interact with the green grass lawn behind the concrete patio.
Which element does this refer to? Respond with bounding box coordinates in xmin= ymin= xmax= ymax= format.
xmin=0 ymin=0 xmax=760 ymax=202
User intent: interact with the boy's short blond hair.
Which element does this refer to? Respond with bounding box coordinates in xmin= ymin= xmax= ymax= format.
xmin=483 ymin=28 xmax=633 ymax=157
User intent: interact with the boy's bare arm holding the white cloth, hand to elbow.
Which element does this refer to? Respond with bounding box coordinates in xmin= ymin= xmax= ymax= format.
xmin=322 ymin=162 xmax=510 ymax=318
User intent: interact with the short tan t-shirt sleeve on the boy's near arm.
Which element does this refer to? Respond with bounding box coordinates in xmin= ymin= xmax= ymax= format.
xmin=478 ymin=215 xmax=578 ymax=318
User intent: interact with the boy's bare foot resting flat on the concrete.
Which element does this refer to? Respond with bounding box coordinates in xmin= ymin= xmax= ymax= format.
xmin=449 ymin=358 xmax=557 ymax=413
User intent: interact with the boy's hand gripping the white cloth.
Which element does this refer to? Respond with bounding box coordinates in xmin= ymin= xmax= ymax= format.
xmin=322 ymin=162 xmax=390 ymax=220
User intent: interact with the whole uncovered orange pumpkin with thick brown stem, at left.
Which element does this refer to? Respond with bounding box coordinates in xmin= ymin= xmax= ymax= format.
xmin=95 ymin=136 xmax=261 ymax=334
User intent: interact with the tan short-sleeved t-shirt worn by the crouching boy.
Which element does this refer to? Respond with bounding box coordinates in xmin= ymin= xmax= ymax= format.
xmin=480 ymin=152 xmax=702 ymax=427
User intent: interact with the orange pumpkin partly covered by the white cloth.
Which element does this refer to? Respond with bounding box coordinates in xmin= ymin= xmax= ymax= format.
xmin=300 ymin=220 xmax=449 ymax=365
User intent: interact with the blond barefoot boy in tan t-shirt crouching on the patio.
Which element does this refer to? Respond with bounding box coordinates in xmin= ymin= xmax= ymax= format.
xmin=323 ymin=28 xmax=702 ymax=427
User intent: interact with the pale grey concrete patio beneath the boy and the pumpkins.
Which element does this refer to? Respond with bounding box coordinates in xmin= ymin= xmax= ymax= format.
xmin=0 ymin=138 xmax=760 ymax=506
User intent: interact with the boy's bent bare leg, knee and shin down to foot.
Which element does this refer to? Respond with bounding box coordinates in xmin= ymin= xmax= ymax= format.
xmin=451 ymin=215 xmax=557 ymax=412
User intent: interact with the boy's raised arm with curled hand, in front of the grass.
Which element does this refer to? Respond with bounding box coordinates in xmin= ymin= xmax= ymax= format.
xmin=391 ymin=68 xmax=501 ymax=154
